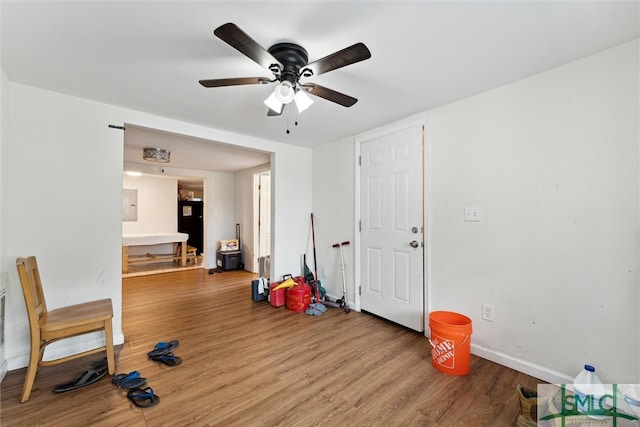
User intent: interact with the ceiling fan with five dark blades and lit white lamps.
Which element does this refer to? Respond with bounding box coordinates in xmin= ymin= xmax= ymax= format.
xmin=200 ymin=22 xmax=371 ymax=116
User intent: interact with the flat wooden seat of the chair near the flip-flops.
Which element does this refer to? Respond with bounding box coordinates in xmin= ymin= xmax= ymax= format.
xmin=39 ymin=298 xmax=113 ymax=338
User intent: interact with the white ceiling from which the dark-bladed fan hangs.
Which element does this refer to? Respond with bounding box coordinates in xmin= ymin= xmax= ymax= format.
xmin=1 ymin=0 xmax=640 ymax=172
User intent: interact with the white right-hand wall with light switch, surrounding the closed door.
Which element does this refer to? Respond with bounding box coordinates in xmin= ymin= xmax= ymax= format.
xmin=313 ymin=40 xmax=640 ymax=383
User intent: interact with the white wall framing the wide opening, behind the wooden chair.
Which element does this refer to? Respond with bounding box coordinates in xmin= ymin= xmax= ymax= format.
xmin=1 ymin=82 xmax=311 ymax=369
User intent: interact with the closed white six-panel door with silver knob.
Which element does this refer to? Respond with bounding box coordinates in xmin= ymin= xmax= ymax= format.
xmin=360 ymin=125 xmax=424 ymax=331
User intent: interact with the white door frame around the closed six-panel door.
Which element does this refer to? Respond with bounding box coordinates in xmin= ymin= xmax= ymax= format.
xmin=353 ymin=118 xmax=431 ymax=335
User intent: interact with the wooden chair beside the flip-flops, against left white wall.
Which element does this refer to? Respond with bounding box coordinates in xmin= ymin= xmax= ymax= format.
xmin=16 ymin=256 xmax=116 ymax=402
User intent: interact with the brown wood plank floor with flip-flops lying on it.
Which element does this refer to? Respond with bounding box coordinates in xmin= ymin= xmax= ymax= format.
xmin=1 ymin=270 xmax=539 ymax=427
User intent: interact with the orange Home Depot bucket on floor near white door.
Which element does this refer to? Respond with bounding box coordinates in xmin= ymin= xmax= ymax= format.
xmin=429 ymin=311 xmax=471 ymax=375
